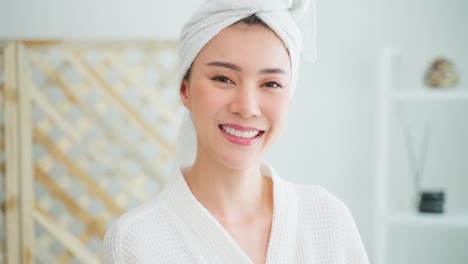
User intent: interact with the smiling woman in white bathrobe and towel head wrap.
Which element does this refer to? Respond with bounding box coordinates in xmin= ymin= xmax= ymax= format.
xmin=104 ymin=0 xmax=368 ymax=264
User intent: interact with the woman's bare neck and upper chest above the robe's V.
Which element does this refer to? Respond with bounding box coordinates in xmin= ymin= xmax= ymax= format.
xmin=185 ymin=152 xmax=272 ymax=223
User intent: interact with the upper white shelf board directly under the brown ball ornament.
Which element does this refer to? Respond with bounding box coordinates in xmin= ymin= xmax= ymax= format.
xmin=392 ymin=88 xmax=468 ymax=102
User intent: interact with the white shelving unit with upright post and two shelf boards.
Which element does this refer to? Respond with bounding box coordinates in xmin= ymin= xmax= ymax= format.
xmin=373 ymin=49 xmax=468 ymax=264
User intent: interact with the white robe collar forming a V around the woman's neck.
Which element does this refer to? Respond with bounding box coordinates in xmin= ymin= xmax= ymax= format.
xmin=162 ymin=163 xmax=298 ymax=263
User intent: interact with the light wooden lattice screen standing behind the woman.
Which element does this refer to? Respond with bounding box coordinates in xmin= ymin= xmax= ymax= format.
xmin=0 ymin=42 xmax=181 ymax=263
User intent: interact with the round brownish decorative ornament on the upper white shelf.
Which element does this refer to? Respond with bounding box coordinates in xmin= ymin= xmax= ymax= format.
xmin=425 ymin=58 xmax=458 ymax=88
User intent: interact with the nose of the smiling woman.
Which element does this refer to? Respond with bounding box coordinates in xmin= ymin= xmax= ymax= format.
xmin=229 ymin=84 xmax=261 ymax=118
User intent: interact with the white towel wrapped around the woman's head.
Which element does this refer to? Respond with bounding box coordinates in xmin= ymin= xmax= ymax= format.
xmin=175 ymin=0 xmax=316 ymax=170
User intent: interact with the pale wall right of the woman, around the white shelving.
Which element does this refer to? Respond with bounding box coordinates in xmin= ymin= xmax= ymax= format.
xmin=271 ymin=0 xmax=468 ymax=263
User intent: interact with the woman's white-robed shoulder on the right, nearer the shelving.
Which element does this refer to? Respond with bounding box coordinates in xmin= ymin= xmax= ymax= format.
xmin=293 ymin=184 xmax=369 ymax=263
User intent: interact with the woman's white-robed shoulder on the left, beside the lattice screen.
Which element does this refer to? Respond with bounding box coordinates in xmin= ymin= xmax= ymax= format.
xmin=103 ymin=194 xmax=175 ymax=263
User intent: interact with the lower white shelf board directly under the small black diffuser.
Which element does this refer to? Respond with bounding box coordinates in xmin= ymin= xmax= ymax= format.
xmin=387 ymin=212 xmax=468 ymax=228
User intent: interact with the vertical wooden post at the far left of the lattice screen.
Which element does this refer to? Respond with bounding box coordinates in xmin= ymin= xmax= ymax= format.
xmin=1 ymin=41 xmax=33 ymax=263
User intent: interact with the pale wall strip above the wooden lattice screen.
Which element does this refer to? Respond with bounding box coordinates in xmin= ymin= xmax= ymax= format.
xmin=0 ymin=0 xmax=202 ymax=40
